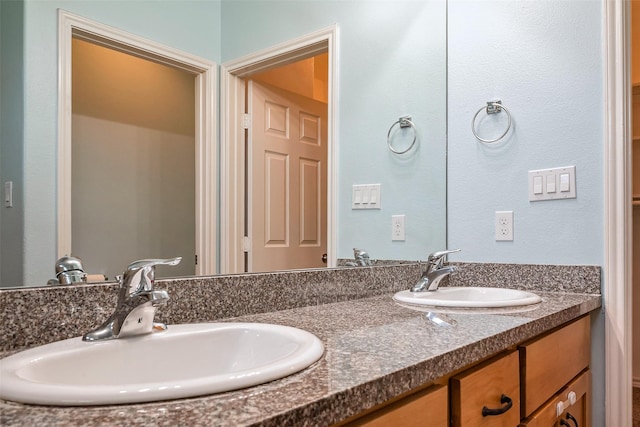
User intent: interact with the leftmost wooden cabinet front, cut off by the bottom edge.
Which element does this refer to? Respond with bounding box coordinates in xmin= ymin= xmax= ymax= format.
xmin=345 ymin=386 xmax=449 ymax=427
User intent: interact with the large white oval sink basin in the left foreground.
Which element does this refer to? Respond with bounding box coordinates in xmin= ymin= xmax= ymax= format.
xmin=0 ymin=323 xmax=324 ymax=406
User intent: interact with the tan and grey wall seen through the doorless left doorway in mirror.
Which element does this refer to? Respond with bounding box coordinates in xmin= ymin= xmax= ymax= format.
xmin=71 ymin=37 xmax=196 ymax=280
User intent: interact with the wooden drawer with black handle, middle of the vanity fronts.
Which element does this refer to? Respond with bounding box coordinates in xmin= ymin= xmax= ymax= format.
xmin=451 ymin=351 xmax=520 ymax=427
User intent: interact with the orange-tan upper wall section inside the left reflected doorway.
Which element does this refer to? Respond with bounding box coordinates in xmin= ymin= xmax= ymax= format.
xmin=72 ymin=38 xmax=195 ymax=136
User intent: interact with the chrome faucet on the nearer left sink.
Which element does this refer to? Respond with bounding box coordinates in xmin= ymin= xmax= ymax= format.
xmin=82 ymin=257 xmax=182 ymax=341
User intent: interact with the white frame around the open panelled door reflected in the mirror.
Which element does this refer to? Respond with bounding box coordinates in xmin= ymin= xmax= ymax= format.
xmin=220 ymin=25 xmax=338 ymax=274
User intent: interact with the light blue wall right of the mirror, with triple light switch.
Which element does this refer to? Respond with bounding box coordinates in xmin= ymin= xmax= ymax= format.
xmin=447 ymin=0 xmax=606 ymax=426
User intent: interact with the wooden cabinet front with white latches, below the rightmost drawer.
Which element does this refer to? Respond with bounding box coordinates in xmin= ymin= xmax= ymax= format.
xmin=520 ymin=370 xmax=591 ymax=427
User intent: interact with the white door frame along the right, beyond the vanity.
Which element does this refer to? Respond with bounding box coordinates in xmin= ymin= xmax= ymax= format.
xmin=595 ymin=0 xmax=633 ymax=427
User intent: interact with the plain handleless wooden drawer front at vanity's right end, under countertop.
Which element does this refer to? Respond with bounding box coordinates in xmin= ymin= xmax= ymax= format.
xmin=519 ymin=316 xmax=591 ymax=418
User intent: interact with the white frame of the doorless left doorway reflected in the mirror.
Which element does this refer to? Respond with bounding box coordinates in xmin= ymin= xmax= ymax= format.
xmin=57 ymin=10 xmax=217 ymax=275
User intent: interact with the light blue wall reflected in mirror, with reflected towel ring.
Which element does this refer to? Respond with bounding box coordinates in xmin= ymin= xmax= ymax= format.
xmin=222 ymin=0 xmax=446 ymax=259
